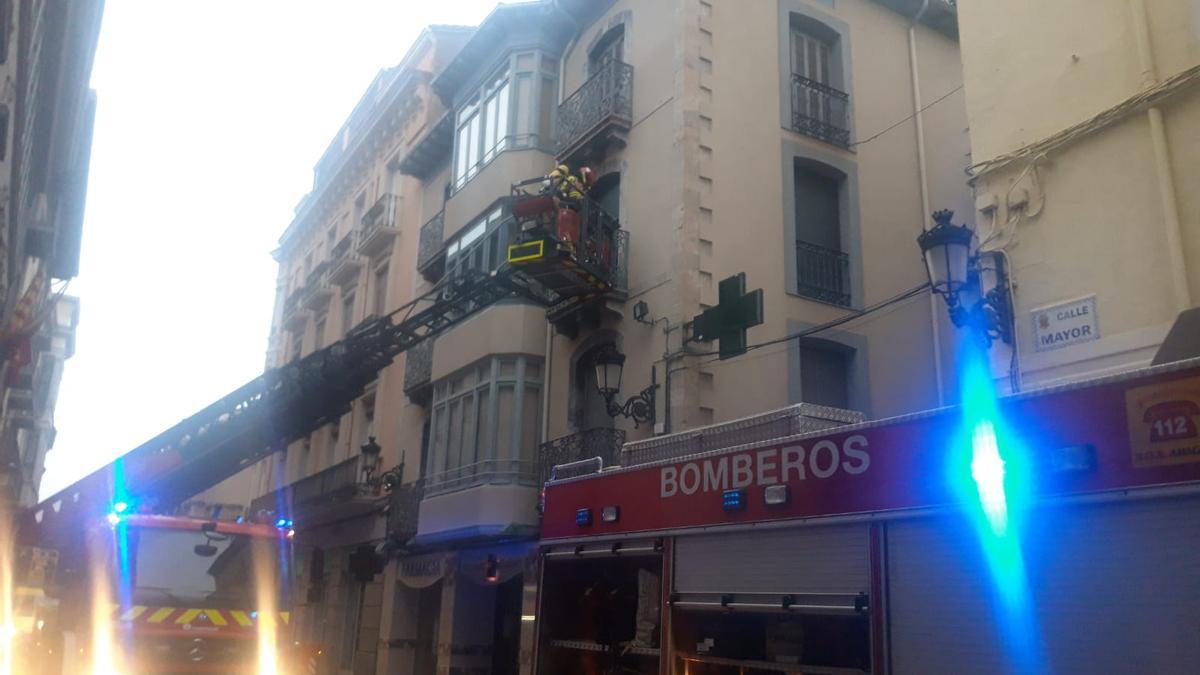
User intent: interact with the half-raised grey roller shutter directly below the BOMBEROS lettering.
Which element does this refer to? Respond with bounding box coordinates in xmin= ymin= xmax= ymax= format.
xmin=674 ymin=525 xmax=870 ymax=595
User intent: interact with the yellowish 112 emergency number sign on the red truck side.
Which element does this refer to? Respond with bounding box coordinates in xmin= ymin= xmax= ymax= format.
xmin=1126 ymin=377 xmax=1200 ymax=467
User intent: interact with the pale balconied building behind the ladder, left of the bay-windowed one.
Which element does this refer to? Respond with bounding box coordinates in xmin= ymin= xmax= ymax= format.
xmin=194 ymin=26 xmax=470 ymax=673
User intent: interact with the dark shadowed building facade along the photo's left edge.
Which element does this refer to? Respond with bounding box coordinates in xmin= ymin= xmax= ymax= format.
xmin=0 ymin=0 xmax=103 ymax=512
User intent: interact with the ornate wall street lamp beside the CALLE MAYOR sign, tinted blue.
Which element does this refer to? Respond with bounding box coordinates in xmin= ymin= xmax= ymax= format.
xmin=917 ymin=209 xmax=1013 ymax=346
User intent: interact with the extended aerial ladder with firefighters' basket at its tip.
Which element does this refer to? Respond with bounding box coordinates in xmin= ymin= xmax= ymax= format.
xmin=20 ymin=167 xmax=623 ymax=552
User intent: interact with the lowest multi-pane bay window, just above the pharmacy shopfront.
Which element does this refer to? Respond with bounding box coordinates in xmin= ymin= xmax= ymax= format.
xmin=426 ymin=357 xmax=541 ymax=491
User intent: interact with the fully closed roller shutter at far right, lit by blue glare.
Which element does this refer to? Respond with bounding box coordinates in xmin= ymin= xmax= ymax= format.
xmin=887 ymin=497 xmax=1200 ymax=675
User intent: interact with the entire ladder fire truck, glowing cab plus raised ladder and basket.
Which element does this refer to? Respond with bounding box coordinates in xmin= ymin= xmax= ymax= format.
xmin=19 ymin=167 xmax=628 ymax=675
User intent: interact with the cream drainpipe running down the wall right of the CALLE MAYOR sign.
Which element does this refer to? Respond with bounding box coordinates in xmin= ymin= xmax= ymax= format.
xmin=1129 ymin=0 xmax=1192 ymax=311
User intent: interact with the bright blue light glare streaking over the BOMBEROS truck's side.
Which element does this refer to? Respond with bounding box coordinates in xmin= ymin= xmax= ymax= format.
xmin=948 ymin=340 xmax=1045 ymax=673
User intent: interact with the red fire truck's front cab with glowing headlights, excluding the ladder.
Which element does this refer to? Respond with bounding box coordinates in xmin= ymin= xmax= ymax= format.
xmin=23 ymin=503 xmax=320 ymax=675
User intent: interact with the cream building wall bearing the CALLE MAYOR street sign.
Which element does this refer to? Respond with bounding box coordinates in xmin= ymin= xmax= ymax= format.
xmin=960 ymin=0 xmax=1200 ymax=388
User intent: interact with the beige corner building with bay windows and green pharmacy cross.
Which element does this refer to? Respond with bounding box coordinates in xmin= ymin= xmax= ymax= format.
xmin=380 ymin=0 xmax=971 ymax=674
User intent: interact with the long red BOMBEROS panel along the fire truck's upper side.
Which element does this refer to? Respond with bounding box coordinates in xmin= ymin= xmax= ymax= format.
xmin=542 ymin=360 xmax=1200 ymax=539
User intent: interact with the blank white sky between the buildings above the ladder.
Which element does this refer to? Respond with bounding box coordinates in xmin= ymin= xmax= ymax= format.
xmin=41 ymin=0 xmax=496 ymax=498
